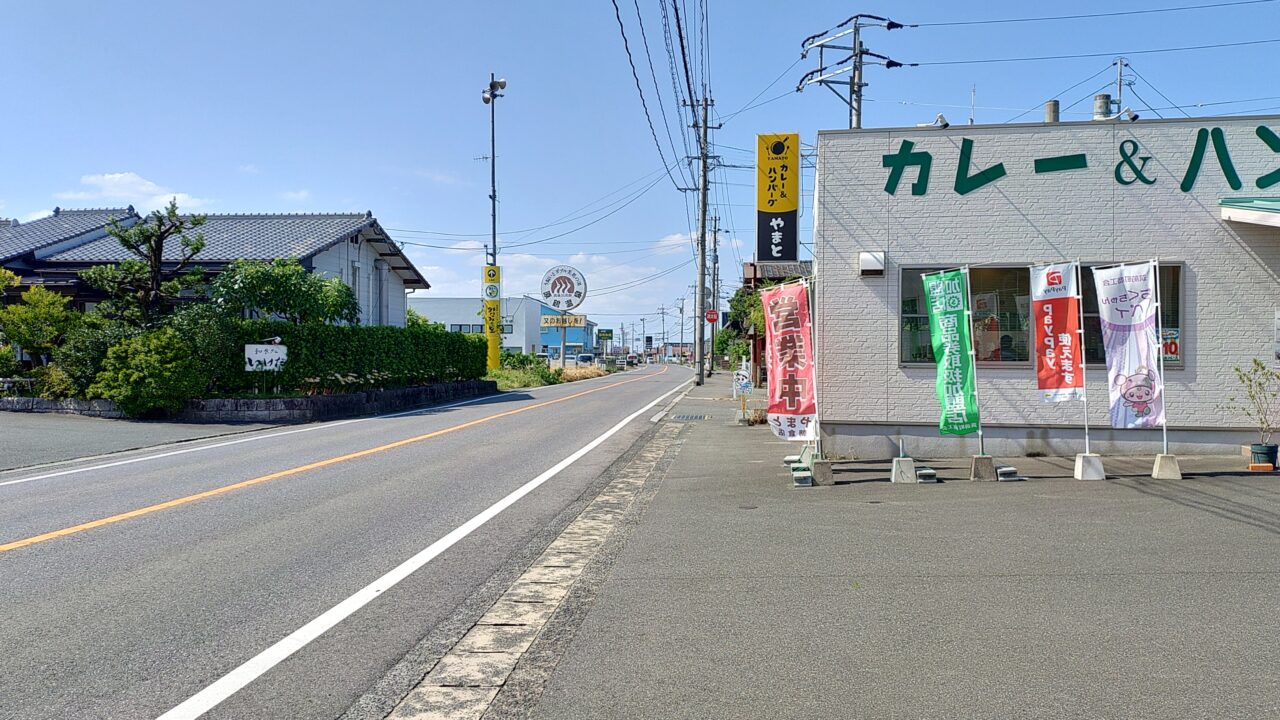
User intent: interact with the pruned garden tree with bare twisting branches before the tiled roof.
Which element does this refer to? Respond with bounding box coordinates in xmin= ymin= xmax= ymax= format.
xmin=79 ymin=199 xmax=207 ymax=327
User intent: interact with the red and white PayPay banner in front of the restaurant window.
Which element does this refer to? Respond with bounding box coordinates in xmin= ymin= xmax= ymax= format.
xmin=1032 ymin=263 xmax=1084 ymax=402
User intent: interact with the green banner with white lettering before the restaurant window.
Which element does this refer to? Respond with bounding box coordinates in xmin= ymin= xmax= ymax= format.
xmin=924 ymin=270 xmax=978 ymax=436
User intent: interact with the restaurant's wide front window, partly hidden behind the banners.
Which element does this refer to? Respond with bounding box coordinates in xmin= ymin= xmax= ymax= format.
xmin=899 ymin=265 xmax=1184 ymax=366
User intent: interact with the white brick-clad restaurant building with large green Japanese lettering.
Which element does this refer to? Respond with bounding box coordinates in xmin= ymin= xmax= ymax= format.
xmin=814 ymin=107 xmax=1280 ymax=457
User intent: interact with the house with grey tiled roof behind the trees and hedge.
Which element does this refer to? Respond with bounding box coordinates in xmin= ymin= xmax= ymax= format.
xmin=0 ymin=208 xmax=431 ymax=325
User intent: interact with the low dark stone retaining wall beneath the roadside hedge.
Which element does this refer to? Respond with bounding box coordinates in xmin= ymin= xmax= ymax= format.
xmin=0 ymin=380 xmax=498 ymax=423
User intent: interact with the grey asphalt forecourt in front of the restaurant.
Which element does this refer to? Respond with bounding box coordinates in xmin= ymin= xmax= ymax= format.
xmin=517 ymin=374 xmax=1280 ymax=720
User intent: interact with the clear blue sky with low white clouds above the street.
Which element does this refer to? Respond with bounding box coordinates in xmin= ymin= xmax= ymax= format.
xmin=0 ymin=0 xmax=1280 ymax=338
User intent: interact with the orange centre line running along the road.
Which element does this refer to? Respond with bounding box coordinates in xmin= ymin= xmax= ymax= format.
xmin=0 ymin=368 xmax=680 ymax=552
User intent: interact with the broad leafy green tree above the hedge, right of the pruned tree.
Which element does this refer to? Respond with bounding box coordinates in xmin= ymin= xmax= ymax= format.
xmin=210 ymin=259 xmax=360 ymax=325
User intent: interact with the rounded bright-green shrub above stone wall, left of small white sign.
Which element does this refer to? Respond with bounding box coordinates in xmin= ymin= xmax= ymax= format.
xmin=88 ymin=327 xmax=209 ymax=418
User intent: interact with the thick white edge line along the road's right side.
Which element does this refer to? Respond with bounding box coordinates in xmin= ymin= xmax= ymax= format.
xmin=157 ymin=369 xmax=692 ymax=720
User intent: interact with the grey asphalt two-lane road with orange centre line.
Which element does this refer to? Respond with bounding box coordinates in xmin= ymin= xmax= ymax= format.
xmin=0 ymin=366 xmax=691 ymax=720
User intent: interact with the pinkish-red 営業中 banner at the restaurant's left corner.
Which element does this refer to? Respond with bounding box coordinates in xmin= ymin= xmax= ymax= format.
xmin=760 ymin=282 xmax=818 ymax=441
